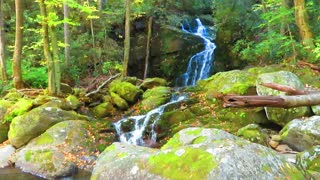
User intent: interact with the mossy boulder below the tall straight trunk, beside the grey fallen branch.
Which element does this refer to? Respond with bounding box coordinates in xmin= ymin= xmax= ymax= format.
xmin=109 ymin=80 xmax=142 ymax=103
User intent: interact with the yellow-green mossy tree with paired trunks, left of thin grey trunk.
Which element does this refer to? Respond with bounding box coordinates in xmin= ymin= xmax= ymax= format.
xmin=39 ymin=0 xmax=61 ymax=95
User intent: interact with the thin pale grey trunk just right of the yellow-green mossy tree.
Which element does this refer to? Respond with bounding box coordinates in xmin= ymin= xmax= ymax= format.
xmin=63 ymin=1 xmax=70 ymax=67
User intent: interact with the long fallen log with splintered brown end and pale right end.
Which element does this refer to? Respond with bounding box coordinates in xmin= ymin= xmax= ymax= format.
xmin=223 ymin=93 xmax=320 ymax=108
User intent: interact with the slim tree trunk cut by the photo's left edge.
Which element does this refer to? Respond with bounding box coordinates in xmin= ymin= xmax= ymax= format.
xmin=0 ymin=0 xmax=8 ymax=83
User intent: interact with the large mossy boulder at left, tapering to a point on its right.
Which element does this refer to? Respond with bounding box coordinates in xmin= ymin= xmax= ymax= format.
xmin=8 ymin=107 xmax=88 ymax=148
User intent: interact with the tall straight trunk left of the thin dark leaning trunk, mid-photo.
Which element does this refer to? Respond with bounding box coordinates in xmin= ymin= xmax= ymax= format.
xmin=122 ymin=0 xmax=130 ymax=76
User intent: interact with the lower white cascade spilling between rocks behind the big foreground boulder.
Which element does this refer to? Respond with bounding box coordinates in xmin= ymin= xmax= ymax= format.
xmin=114 ymin=95 xmax=187 ymax=146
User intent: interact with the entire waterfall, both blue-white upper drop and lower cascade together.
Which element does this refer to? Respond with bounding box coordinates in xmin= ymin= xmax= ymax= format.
xmin=114 ymin=19 xmax=216 ymax=146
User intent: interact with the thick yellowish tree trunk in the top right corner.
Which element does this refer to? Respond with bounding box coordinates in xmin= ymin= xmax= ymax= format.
xmin=293 ymin=0 xmax=314 ymax=48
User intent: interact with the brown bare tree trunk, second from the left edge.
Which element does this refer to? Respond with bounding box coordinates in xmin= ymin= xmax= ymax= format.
xmin=12 ymin=0 xmax=23 ymax=89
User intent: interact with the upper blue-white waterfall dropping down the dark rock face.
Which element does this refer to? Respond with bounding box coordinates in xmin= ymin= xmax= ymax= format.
xmin=176 ymin=18 xmax=216 ymax=86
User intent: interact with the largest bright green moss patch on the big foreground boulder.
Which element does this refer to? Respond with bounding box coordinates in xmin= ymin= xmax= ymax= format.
xmin=148 ymin=148 xmax=217 ymax=179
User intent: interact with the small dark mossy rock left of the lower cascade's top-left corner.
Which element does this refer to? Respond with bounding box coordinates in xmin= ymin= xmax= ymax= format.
xmin=91 ymin=102 xmax=116 ymax=118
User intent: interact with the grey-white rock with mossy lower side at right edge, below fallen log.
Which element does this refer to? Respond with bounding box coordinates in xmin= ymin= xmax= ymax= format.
xmin=280 ymin=116 xmax=320 ymax=151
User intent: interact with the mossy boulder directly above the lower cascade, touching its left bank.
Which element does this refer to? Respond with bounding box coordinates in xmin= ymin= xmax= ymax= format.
xmin=140 ymin=86 xmax=171 ymax=111
